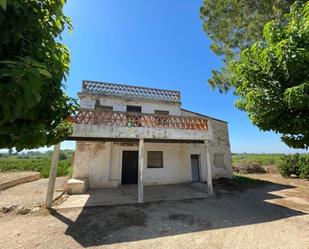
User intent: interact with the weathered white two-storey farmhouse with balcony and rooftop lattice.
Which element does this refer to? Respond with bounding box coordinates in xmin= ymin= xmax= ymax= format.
xmin=69 ymin=81 xmax=232 ymax=201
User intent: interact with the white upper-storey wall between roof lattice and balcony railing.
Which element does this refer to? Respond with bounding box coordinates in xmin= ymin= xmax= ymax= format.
xmin=80 ymin=95 xmax=181 ymax=115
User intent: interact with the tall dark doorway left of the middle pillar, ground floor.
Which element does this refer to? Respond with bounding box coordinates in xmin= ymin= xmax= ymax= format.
xmin=121 ymin=151 xmax=138 ymax=184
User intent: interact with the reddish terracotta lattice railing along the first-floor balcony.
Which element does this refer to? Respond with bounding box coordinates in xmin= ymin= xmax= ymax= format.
xmin=71 ymin=109 xmax=208 ymax=131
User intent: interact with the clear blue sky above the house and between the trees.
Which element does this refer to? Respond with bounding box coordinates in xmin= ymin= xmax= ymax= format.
xmin=56 ymin=0 xmax=305 ymax=153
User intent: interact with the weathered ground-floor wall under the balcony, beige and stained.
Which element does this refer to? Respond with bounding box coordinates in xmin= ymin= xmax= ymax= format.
xmin=73 ymin=142 xmax=227 ymax=188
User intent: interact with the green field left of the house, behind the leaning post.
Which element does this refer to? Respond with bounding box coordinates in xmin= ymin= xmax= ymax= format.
xmin=0 ymin=151 xmax=72 ymax=177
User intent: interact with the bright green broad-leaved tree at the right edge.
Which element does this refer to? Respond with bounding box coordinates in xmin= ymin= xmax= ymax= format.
xmin=229 ymin=2 xmax=309 ymax=149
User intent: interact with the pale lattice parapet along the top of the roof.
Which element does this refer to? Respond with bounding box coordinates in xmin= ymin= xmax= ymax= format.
xmin=83 ymin=80 xmax=180 ymax=102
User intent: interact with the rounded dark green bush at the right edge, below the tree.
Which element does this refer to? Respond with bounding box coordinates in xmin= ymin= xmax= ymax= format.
xmin=278 ymin=154 xmax=309 ymax=179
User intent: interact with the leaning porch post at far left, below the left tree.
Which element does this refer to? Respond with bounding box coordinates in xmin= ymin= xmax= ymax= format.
xmin=46 ymin=143 xmax=60 ymax=208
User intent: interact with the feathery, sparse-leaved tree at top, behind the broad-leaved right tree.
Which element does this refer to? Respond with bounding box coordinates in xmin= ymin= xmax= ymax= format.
xmin=200 ymin=0 xmax=294 ymax=92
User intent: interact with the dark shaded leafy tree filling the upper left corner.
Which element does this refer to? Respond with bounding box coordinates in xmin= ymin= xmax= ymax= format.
xmin=0 ymin=0 xmax=76 ymax=150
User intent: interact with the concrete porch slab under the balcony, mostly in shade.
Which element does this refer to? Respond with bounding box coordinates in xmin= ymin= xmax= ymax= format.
xmin=55 ymin=183 xmax=208 ymax=210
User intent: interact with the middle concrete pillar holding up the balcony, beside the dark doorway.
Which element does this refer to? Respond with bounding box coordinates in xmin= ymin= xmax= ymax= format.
xmin=137 ymin=138 xmax=145 ymax=203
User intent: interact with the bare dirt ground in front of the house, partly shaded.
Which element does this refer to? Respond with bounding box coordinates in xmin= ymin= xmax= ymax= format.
xmin=0 ymin=175 xmax=309 ymax=249
